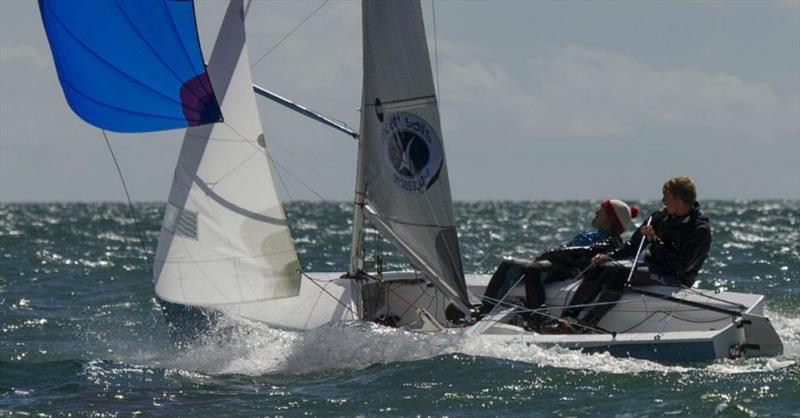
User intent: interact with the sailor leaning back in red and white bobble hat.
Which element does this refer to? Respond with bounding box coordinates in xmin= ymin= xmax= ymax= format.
xmin=481 ymin=199 xmax=639 ymax=313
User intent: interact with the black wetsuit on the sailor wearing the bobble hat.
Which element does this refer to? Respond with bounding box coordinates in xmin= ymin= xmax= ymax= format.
xmin=482 ymin=235 xmax=622 ymax=311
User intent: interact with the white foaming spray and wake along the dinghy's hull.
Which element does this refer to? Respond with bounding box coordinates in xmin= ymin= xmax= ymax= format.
xmin=120 ymin=312 xmax=800 ymax=376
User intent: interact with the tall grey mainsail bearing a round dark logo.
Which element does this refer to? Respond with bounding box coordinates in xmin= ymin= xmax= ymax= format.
xmin=361 ymin=0 xmax=469 ymax=311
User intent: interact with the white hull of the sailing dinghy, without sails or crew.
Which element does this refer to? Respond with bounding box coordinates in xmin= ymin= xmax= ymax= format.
xmin=161 ymin=272 xmax=782 ymax=361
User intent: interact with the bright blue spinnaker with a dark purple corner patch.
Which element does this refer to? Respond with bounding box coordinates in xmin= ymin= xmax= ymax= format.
xmin=39 ymin=0 xmax=222 ymax=132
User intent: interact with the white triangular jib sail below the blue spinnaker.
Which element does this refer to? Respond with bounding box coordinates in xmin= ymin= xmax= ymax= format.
xmin=154 ymin=0 xmax=300 ymax=306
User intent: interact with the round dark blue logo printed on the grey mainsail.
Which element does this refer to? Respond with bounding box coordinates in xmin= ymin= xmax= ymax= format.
xmin=381 ymin=112 xmax=442 ymax=193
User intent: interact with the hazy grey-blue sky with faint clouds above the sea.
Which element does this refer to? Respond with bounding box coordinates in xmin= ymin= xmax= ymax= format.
xmin=0 ymin=0 xmax=800 ymax=202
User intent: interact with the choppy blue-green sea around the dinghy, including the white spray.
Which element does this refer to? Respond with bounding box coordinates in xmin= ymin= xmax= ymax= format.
xmin=0 ymin=201 xmax=800 ymax=417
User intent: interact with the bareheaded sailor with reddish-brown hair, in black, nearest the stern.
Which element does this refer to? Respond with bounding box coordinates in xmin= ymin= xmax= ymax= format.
xmin=552 ymin=177 xmax=711 ymax=332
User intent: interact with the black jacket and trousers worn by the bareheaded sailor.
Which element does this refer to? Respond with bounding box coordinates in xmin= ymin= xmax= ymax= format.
xmin=564 ymin=203 xmax=711 ymax=325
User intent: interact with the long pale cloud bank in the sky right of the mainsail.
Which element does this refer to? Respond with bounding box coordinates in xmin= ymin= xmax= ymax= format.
xmin=442 ymin=45 xmax=800 ymax=142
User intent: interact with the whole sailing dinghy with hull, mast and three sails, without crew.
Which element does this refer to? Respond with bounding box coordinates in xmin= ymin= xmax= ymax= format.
xmin=39 ymin=0 xmax=782 ymax=361
